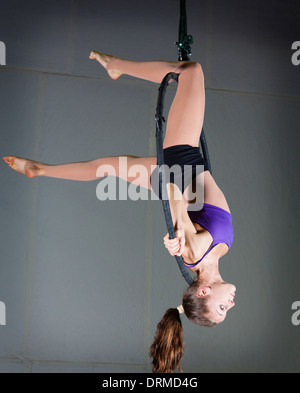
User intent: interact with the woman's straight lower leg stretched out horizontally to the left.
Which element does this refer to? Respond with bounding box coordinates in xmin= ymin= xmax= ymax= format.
xmin=3 ymin=156 xmax=156 ymax=189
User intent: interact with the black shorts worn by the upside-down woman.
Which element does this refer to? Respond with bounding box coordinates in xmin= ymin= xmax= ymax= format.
xmin=150 ymin=145 xmax=209 ymax=199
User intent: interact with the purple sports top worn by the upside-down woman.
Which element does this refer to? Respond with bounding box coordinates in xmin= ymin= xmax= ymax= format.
xmin=185 ymin=203 xmax=234 ymax=268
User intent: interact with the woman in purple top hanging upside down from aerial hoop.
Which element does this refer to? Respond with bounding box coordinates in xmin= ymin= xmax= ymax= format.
xmin=3 ymin=51 xmax=236 ymax=373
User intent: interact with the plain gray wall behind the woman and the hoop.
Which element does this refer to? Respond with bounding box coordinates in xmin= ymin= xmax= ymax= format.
xmin=0 ymin=0 xmax=300 ymax=373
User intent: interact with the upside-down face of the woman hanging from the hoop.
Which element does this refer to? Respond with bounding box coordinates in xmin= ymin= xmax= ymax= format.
xmin=206 ymin=282 xmax=236 ymax=323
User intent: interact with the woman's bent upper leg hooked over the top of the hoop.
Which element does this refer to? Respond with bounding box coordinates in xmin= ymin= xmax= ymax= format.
xmin=90 ymin=51 xmax=205 ymax=147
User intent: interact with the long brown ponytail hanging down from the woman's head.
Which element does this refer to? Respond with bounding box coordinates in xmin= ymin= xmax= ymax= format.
xmin=149 ymin=308 xmax=183 ymax=373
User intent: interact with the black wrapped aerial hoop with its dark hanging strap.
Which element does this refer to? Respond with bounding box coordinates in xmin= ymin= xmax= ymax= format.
xmin=155 ymin=0 xmax=211 ymax=285
